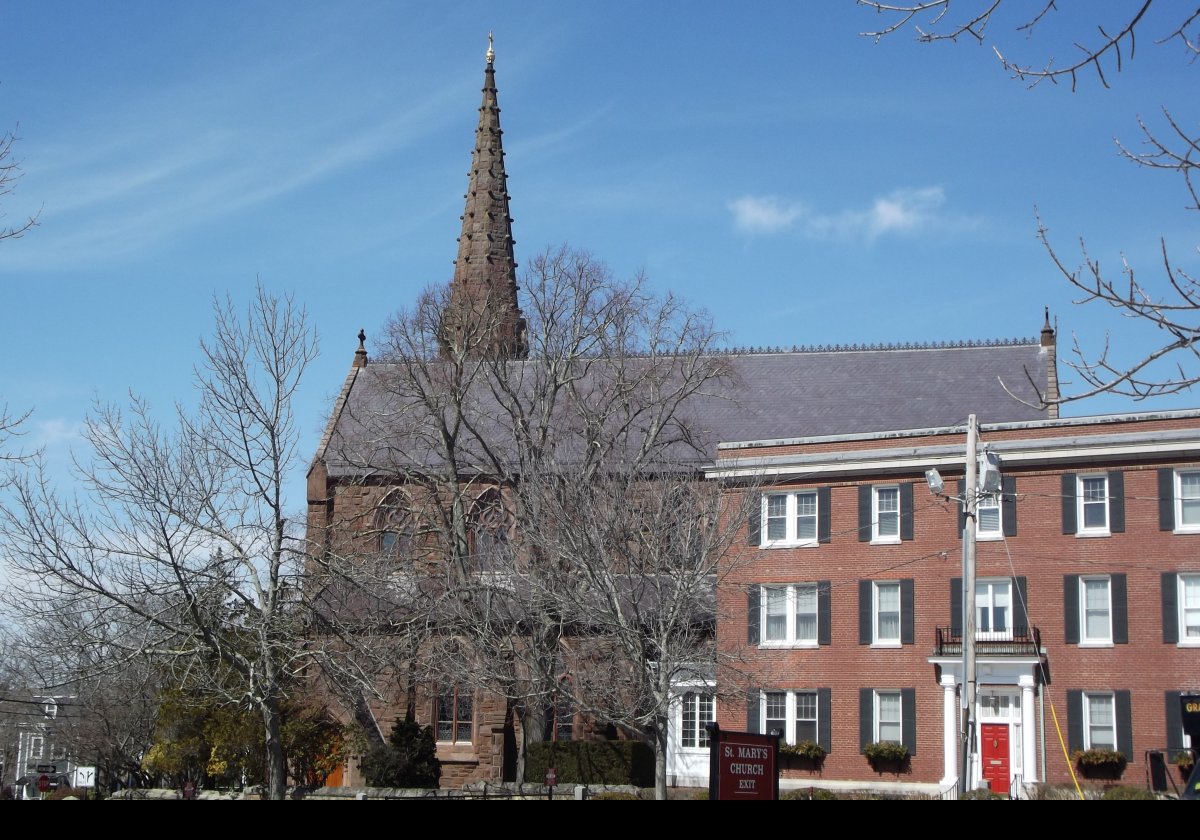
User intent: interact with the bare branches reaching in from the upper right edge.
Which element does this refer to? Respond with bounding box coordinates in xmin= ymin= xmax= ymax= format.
xmin=858 ymin=0 xmax=1200 ymax=406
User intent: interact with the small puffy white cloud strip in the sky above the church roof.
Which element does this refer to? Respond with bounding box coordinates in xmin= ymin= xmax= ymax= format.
xmin=730 ymin=186 xmax=973 ymax=241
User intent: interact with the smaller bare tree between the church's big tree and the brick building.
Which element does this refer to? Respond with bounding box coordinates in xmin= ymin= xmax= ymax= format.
xmin=518 ymin=470 xmax=757 ymax=799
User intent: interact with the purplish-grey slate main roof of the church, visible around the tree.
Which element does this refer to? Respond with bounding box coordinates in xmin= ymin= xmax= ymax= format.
xmin=317 ymin=340 xmax=1052 ymax=476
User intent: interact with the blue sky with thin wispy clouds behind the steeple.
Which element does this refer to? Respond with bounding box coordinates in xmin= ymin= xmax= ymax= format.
xmin=0 ymin=0 xmax=1200 ymax=510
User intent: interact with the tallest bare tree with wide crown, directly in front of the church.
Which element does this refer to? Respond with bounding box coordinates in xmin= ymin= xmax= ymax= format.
xmin=331 ymin=242 xmax=730 ymax=787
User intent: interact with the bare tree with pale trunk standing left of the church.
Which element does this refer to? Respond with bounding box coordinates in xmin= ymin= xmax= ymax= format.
xmin=0 ymin=288 xmax=350 ymax=798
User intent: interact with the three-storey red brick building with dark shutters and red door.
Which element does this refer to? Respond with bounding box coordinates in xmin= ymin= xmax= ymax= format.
xmin=709 ymin=410 xmax=1200 ymax=793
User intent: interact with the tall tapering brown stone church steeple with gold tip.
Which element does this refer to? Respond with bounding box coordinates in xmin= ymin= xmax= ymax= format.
xmin=442 ymin=35 xmax=529 ymax=359
